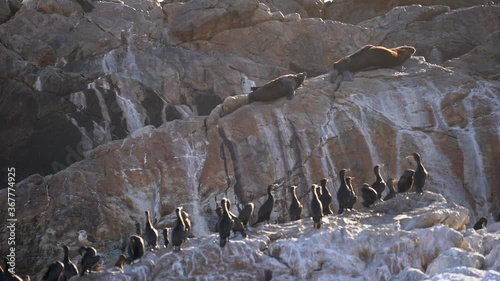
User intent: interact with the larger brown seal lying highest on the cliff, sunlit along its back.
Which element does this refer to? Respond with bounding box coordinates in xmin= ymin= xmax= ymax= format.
xmin=330 ymin=45 xmax=416 ymax=83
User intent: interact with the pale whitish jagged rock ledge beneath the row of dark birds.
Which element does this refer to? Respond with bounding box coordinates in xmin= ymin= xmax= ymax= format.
xmin=60 ymin=192 xmax=500 ymax=281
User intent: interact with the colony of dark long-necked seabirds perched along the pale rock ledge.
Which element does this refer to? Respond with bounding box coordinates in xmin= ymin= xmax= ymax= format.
xmin=0 ymin=153 xmax=487 ymax=281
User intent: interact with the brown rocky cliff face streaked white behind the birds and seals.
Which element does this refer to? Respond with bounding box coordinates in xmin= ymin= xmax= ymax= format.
xmin=0 ymin=0 xmax=500 ymax=278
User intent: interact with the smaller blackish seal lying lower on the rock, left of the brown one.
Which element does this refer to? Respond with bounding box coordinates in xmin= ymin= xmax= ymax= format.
xmin=248 ymin=72 xmax=307 ymax=103
